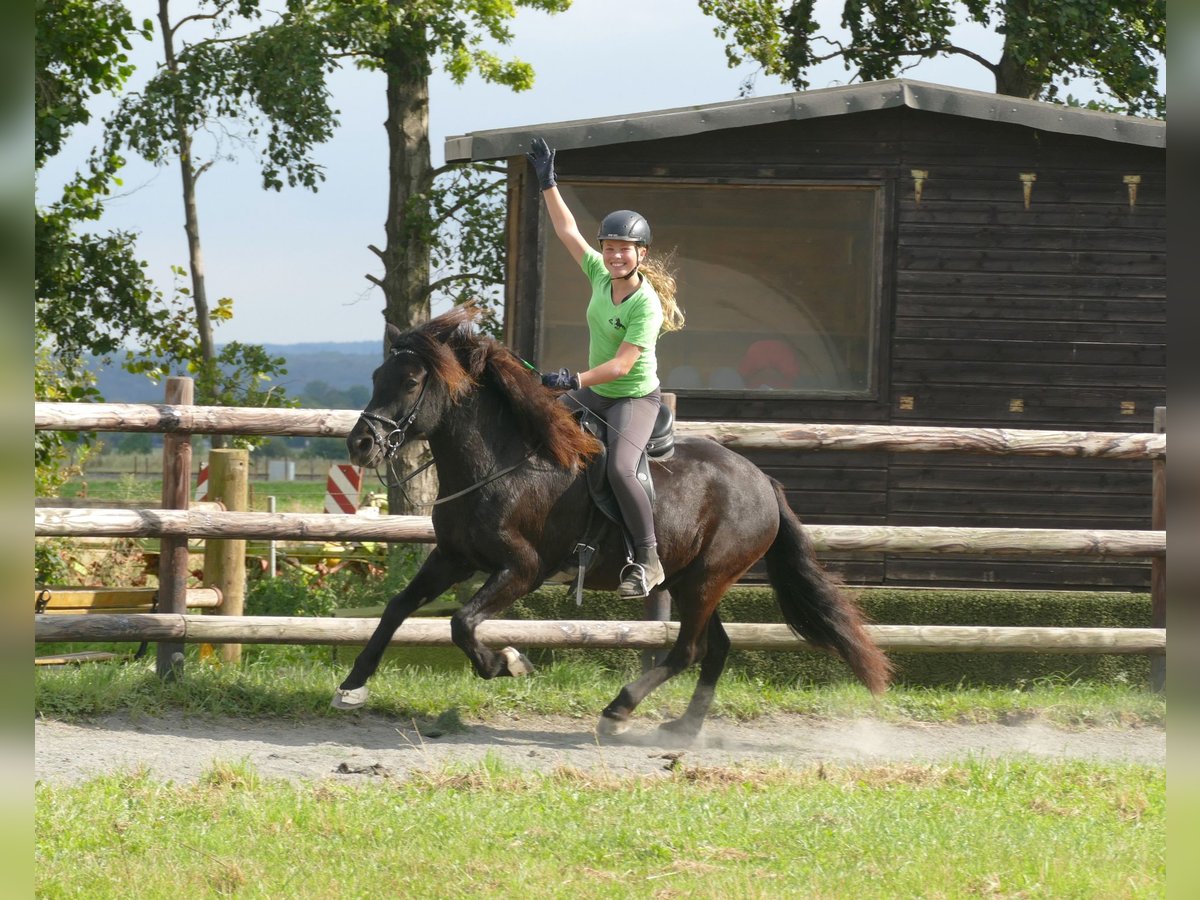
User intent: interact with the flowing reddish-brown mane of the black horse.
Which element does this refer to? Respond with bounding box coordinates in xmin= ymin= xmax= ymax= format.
xmin=400 ymin=304 xmax=600 ymax=472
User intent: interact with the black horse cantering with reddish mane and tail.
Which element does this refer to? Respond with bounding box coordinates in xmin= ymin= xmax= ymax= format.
xmin=334 ymin=306 xmax=892 ymax=737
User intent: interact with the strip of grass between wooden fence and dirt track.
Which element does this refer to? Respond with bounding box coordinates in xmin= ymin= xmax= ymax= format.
xmin=34 ymin=647 xmax=1166 ymax=727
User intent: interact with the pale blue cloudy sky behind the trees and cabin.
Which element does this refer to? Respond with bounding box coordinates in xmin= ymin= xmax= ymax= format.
xmin=38 ymin=0 xmax=1137 ymax=344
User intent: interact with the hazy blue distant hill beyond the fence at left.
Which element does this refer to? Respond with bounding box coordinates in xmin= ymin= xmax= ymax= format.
xmin=92 ymin=341 xmax=383 ymax=403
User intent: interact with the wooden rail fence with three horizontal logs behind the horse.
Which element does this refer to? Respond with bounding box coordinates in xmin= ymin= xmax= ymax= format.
xmin=35 ymin=379 xmax=1166 ymax=686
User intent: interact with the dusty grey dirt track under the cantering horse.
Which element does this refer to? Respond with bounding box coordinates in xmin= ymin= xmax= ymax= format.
xmin=34 ymin=713 xmax=1166 ymax=784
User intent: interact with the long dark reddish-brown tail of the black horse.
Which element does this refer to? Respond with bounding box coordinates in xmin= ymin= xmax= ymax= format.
xmin=766 ymin=479 xmax=892 ymax=694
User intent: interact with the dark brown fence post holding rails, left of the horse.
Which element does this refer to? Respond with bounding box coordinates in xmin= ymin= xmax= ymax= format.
xmin=155 ymin=377 xmax=194 ymax=679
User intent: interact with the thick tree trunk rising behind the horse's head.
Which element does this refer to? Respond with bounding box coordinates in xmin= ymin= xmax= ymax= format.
xmin=380 ymin=19 xmax=437 ymax=515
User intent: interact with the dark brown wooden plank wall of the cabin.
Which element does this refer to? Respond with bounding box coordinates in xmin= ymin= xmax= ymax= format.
xmin=510 ymin=108 xmax=1166 ymax=590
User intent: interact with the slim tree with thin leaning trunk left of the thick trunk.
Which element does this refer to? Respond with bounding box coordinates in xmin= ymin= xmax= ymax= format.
xmin=104 ymin=0 xmax=336 ymax=448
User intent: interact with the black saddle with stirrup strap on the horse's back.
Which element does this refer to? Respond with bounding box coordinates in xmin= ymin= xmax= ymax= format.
xmin=563 ymin=403 xmax=674 ymax=606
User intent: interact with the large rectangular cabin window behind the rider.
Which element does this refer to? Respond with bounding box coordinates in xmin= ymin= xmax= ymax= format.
xmin=539 ymin=181 xmax=882 ymax=397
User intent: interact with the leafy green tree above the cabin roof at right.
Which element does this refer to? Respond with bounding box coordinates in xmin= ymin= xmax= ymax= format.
xmin=700 ymin=0 xmax=1166 ymax=116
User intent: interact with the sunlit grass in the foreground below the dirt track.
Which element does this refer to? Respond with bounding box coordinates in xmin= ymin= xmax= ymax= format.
xmin=35 ymin=758 xmax=1165 ymax=900
